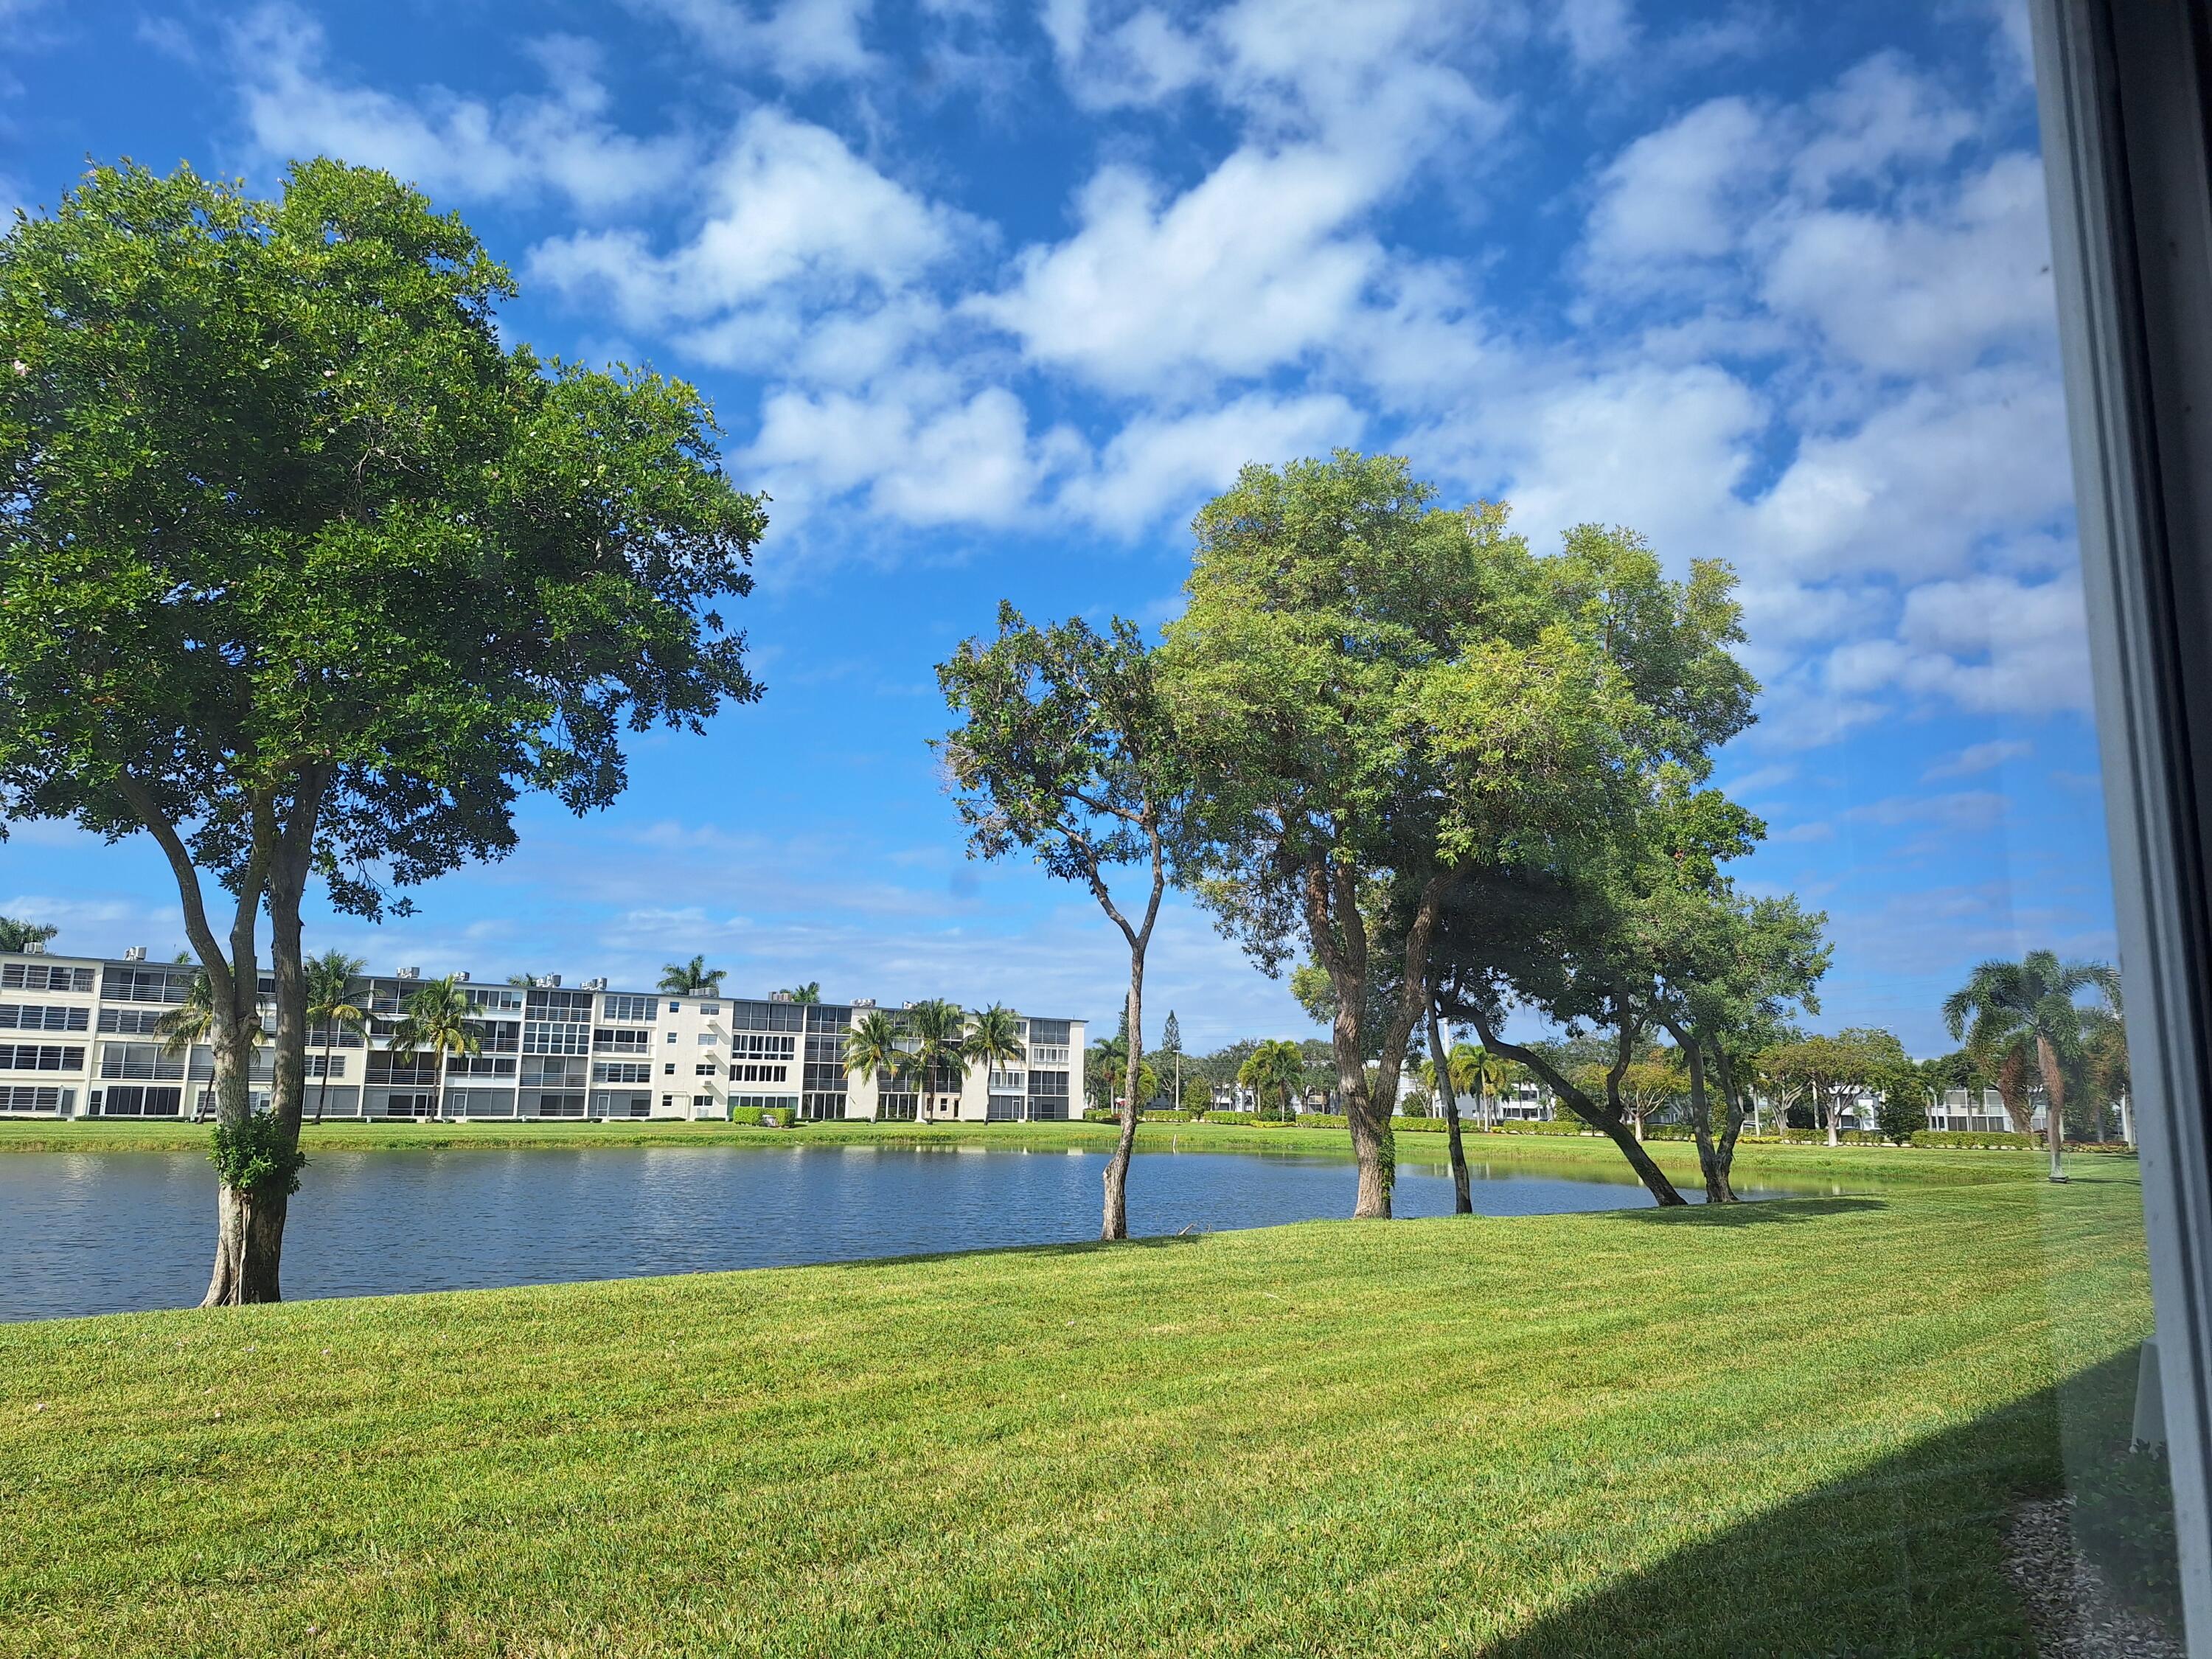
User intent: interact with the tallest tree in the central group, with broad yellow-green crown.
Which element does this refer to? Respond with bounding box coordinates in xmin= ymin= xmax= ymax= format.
xmin=1166 ymin=451 xmax=1752 ymax=1217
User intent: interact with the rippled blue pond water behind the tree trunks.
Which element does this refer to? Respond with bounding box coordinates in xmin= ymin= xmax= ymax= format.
xmin=0 ymin=1146 xmax=1814 ymax=1321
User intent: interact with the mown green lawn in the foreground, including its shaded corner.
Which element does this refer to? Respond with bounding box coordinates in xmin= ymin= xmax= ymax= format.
xmin=0 ymin=1130 xmax=2150 ymax=1659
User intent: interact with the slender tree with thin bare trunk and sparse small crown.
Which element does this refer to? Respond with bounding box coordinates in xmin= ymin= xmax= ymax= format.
xmin=938 ymin=604 xmax=1188 ymax=1239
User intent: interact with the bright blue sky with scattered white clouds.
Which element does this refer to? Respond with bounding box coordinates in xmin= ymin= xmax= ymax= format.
xmin=0 ymin=0 xmax=2112 ymax=1053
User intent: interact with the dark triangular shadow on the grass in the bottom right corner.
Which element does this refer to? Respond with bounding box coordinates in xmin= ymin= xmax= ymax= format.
xmin=1478 ymin=1347 xmax=2135 ymax=1659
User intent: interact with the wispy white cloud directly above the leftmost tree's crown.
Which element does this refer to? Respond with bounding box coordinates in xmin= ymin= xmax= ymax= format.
xmin=230 ymin=4 xmax=690 ymax=210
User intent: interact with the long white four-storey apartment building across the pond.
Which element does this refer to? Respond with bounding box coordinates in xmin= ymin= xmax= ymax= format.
xmin=0 ymin=951 xmax=1084 ymax=1121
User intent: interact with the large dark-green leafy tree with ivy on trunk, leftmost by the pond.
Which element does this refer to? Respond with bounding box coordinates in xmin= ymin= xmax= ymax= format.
xmin=0 ymin=159 xmax=765 ymax=1303
